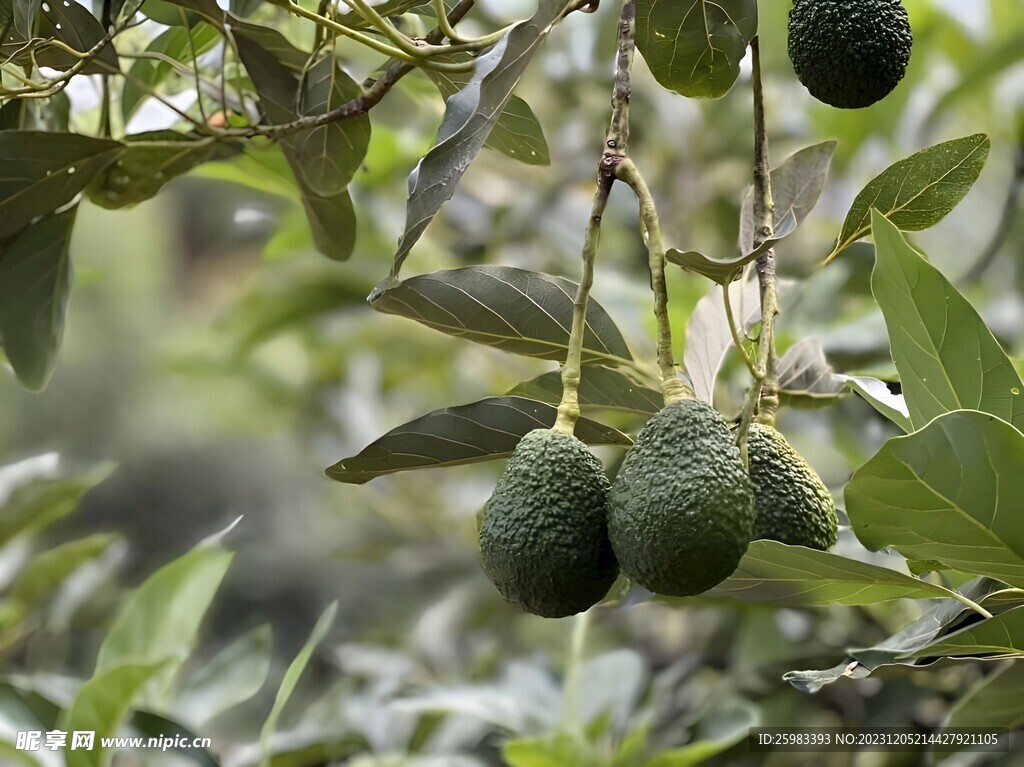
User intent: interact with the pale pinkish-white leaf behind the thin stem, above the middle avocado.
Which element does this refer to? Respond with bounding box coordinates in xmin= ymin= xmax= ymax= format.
xmin=683 ymin=280 xmax=761 ymax=404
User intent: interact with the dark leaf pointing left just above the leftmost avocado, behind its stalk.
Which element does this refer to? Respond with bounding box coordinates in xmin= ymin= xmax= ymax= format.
xmin=327 ymin=396 xmax=630 ymax=484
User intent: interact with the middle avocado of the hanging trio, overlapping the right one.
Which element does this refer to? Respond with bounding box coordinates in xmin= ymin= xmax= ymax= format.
xmin=608 ymin=399 xmax=755 ymax=596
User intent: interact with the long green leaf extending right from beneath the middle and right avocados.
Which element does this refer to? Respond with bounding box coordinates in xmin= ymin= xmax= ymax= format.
xmin=707 ymin=541 xmax=950 ymax=605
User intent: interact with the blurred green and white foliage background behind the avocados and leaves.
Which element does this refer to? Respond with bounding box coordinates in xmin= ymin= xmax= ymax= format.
xmin=0 ymin=0 xmax=1024 ymax=767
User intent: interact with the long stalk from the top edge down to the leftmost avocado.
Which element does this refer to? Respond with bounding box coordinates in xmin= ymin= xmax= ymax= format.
xmin=553 ymin=0 xmax=636 ymax=434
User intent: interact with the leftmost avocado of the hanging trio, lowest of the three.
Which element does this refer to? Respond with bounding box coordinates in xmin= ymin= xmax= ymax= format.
xmin=480 ymin=429 xmax=618 ymax=617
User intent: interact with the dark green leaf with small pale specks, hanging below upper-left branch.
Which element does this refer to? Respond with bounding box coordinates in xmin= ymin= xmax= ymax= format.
xmin=88 ymin=130 xmax=241 ymax=209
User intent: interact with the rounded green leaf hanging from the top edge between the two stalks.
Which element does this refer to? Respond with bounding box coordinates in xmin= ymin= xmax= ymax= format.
xmin=636 ymin=0 xmax=758 ymax=98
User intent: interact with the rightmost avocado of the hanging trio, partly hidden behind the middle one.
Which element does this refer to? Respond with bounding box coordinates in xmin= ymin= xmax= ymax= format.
xmin=746 ymin=424 xmax=839 ymax=551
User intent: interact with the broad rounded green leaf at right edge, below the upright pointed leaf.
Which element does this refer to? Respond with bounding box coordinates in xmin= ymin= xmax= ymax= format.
xmin=846 ymin=411 xmax=1024 ymax=587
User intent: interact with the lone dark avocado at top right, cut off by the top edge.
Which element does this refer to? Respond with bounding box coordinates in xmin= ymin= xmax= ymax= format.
xmin=788 ymin=0 xmax=913 ymax=110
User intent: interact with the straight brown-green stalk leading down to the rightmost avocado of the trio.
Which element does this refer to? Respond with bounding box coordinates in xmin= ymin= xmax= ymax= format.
xmin=737 ymin=36 xmax=778 ymax=464
